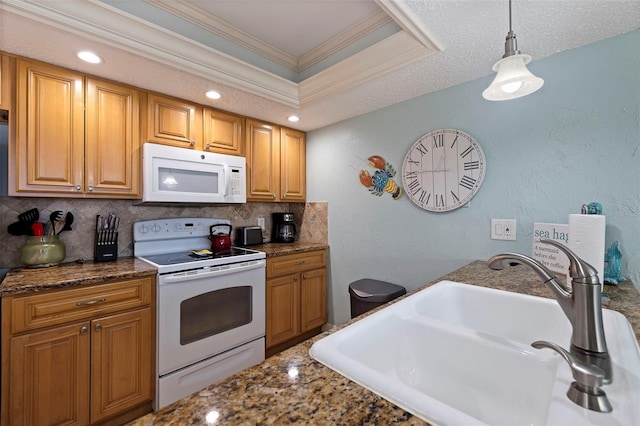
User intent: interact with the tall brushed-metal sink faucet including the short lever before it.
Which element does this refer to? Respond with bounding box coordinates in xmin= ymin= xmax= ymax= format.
xmin=487 ymin=239 xmax=613 ymax=412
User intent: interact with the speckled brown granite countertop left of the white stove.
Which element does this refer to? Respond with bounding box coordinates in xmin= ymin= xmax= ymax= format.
xmin=0 ymin=257 xmax=156 ymax=297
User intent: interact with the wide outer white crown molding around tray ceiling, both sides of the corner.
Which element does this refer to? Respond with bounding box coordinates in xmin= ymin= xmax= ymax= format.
xmin=2 ymin=0 xmax=442 ymax=108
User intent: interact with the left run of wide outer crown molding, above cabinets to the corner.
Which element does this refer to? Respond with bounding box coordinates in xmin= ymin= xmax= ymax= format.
xmin=2 ymin=0 xmax=299 ymax=107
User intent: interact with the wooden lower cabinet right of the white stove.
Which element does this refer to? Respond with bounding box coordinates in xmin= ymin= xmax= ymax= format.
xmin=266 ymin=250 xmax=327 ymax=356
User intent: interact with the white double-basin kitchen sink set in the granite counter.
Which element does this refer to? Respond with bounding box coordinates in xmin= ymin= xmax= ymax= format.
xmin=310 ymin=281 xmax=640 ymax=426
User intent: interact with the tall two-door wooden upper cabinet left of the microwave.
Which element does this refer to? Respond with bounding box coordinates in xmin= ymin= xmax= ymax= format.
xmin=9 ymin=60 xmax=140 ymax=198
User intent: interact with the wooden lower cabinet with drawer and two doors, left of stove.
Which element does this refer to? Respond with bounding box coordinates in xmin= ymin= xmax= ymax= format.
xmin=1 ymin=278 xmax=155 ymax=426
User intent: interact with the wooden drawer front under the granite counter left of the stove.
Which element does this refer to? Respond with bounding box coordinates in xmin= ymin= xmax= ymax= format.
xmin=9 ymin=277 xmax=155 ymax=333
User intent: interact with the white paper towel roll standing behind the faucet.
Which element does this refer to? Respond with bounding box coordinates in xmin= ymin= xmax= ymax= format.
xmin=569 ymin=214 xmax=606 ymax=290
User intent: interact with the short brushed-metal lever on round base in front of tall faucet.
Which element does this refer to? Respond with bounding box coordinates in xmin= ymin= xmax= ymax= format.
xmin=531 ymin=340 xmax=613 ymax=413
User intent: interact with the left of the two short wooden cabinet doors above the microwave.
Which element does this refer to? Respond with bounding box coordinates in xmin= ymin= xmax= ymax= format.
xmin=144 ymin=93 xmax=202 ymax=149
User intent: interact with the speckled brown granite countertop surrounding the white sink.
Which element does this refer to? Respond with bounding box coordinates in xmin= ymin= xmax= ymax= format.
xmin=131 ymin=261 xmax=640 ymax=426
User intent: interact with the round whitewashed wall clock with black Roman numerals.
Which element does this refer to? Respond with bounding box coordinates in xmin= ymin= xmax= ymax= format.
xmin=402 ymin=129 xmax=486 ymax=212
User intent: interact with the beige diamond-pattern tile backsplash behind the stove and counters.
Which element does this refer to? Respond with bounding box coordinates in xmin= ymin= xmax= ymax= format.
xmin=0 ymin=197 xmax=329 ymax=268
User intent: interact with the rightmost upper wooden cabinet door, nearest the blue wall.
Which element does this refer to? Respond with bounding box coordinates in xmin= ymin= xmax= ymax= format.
xmin=280 ymin=128 xmax=307 ymax=201
